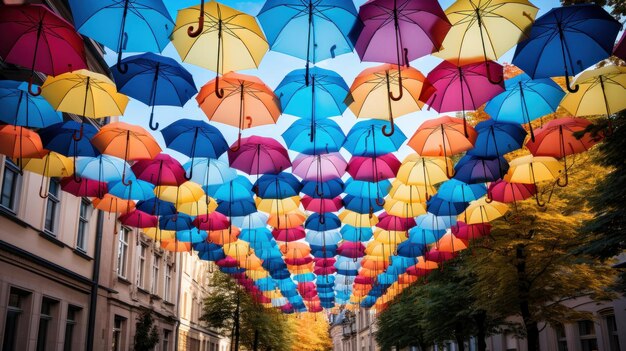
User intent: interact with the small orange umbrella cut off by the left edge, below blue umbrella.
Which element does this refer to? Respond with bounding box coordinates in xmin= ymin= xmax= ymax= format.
xmin=0 ymin=125 xmax=44 ymax=169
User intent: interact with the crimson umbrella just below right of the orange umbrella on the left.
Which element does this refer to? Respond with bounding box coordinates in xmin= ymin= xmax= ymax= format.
xmin=131 ymin=154 xmax=187 ymax=186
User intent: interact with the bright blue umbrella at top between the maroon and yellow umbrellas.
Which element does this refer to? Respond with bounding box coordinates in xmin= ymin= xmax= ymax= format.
xmin=69 ymin=0 xmax=174 ymax=73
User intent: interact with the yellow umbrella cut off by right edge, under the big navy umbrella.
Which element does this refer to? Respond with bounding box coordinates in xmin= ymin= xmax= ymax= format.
xmin=561 ymin=65 xmax=626 ymax=116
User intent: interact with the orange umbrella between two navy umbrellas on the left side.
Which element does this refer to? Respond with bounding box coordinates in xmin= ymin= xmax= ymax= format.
xmin=91 ymin=122 xmax=161 ymax=185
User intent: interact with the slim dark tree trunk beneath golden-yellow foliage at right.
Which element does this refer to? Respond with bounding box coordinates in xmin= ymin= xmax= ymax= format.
xmin=515 ymin=244 xmax=539 ymax=351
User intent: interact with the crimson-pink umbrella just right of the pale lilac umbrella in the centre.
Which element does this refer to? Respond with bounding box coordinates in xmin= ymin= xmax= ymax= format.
xmin=347 ymin=154 xmax=401 ymax=182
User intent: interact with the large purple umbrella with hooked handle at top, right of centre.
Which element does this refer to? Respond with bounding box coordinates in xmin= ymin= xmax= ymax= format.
xmin=355 ymin=0 xmax=450 ymax=101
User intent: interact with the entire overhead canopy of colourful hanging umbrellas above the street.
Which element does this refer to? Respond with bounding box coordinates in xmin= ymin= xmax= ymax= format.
xmin=0 ymin=0 xmax=626 ymax=313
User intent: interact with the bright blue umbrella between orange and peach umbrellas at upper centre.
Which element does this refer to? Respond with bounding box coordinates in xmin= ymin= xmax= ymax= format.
xmin=274 ymin=67 xmax=350 ymax=142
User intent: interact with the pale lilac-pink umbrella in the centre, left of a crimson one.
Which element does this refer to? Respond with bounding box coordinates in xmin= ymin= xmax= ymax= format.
xmin=293 ymin=152 xmax=348 ymax=182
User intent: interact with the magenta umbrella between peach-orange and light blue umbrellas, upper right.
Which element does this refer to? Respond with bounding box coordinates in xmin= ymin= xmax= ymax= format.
xmin=420 ymin=61 xmax=504 ymax=137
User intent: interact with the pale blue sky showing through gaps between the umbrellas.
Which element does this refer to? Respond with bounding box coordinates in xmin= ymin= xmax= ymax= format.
xmin=105 ymin=0 xmax=560 ymax=162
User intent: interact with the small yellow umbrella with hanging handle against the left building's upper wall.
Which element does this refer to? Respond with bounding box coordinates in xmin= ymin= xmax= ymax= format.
xmin=21 ymin=151 xmax=74 ymax=199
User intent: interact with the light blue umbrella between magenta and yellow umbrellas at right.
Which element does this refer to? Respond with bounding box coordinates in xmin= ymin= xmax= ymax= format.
xmin=485 ymin=73 xmax=565 ymax=141
